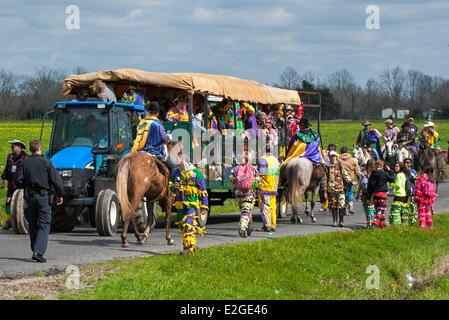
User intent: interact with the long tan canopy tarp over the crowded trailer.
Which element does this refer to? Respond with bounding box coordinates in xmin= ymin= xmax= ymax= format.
xmin=63 ymin=69 xmax=301 ymax=105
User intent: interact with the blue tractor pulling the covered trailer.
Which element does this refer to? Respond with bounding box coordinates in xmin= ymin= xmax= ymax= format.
xmin=11 ymin=101 xmax=147 ymax=236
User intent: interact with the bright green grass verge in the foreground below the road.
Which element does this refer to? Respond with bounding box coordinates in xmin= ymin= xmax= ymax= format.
xmin=60 ymin=215 xmax=449 ymax=300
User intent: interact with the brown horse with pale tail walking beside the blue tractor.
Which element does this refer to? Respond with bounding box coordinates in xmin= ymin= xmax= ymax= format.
xmin=116 ymin=152 xmax=174 ymax=248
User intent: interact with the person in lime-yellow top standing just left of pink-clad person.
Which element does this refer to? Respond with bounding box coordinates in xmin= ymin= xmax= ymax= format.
xmin=389 ymin=163 xmax=414 ymax=225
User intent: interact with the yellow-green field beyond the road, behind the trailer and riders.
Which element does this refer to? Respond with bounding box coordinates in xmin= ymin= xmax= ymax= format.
xmin=0 ymin=120 xmax=449 ymax=226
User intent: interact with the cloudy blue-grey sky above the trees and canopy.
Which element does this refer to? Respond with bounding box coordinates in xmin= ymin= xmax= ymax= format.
xmin=0 ymin=0 xmax=449 ymax=84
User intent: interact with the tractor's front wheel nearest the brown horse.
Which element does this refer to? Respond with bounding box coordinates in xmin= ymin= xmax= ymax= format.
xmin=95 ymin=189 xmax=120 ymax=237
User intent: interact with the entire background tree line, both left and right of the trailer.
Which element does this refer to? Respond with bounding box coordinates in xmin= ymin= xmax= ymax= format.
xmin=0 ymin=67 xmax=449 ymax=120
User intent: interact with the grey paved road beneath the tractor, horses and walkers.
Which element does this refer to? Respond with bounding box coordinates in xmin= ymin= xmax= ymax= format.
xmin=0 ymin=183 xmax=449 ymax=278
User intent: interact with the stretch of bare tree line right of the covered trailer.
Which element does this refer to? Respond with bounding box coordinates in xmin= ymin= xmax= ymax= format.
xmin=274 ymin=67 xmax=449 ymax=120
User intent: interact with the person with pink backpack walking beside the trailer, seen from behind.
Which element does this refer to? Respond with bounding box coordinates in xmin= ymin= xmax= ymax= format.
xmin=229 ymin=153 xmax=259 ymax=238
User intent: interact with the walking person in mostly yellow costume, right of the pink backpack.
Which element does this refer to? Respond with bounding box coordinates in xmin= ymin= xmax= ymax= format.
xmin=257 ymin=144 xmax=279 ymax=232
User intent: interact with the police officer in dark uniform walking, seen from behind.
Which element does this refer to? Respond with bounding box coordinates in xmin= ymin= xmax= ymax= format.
xmin=15 ymin=140 xmax=64 ymax=262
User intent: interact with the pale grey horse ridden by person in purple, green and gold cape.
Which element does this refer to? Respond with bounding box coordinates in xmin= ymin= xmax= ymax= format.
xmin=280 ymin=158 xmax=320 ymax=224
